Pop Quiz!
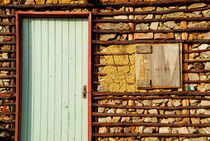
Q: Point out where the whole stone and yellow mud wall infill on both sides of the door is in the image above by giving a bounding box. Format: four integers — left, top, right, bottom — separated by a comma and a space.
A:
0, 0, 210, 141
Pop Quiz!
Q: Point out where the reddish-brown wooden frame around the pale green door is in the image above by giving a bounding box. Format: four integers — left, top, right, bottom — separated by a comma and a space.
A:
15, 11, 92, 141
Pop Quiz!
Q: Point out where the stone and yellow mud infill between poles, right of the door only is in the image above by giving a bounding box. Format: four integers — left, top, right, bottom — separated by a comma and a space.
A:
94, 3, 210, 141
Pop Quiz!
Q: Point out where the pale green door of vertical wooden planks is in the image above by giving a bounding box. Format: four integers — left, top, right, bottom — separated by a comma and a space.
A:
21, 18, 88, 141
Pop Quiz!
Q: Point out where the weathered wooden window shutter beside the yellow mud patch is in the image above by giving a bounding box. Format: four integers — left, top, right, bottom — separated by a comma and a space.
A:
136, 44, 181, 89
